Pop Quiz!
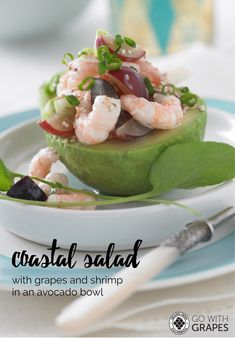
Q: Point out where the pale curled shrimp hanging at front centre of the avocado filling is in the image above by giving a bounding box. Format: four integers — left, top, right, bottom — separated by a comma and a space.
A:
74, 95, 121, 144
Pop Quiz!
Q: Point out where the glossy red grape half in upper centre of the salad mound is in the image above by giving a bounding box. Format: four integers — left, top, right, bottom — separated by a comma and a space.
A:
106, 67, 149, 99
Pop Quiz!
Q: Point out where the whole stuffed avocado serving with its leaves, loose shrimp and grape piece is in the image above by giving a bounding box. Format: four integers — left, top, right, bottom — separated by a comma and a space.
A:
3, 31, 235, 212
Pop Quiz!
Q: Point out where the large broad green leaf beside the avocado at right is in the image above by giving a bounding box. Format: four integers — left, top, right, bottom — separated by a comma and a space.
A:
150, 142, 235, 194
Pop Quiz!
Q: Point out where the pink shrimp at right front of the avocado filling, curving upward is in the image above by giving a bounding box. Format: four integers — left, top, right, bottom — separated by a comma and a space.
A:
121, 95, 183, 129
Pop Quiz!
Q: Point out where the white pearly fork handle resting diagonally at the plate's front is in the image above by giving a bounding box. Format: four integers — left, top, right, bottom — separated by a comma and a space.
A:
56, 246, 180, 333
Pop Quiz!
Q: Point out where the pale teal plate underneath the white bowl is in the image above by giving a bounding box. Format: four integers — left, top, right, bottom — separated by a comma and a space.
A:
0, 99, 235, 290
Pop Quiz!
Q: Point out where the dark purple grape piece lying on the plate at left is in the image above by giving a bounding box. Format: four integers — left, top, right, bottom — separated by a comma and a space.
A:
7, 176, 47, 202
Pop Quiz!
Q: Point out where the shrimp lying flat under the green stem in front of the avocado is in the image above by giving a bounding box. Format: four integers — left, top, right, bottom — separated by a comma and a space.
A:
47, 193, 96, 210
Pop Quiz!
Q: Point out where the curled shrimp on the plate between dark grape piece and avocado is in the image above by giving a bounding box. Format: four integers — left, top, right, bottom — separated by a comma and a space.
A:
28, 148, 59, 178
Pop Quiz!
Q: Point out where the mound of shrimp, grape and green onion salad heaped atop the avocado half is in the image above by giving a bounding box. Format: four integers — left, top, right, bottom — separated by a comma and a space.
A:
39, 31, 200, 145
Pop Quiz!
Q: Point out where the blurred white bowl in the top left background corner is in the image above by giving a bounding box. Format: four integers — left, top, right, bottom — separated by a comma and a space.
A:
0, 0, 89, 40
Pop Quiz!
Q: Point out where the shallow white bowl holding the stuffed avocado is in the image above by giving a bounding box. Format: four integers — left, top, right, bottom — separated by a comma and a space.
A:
0, 109, 235, 250
